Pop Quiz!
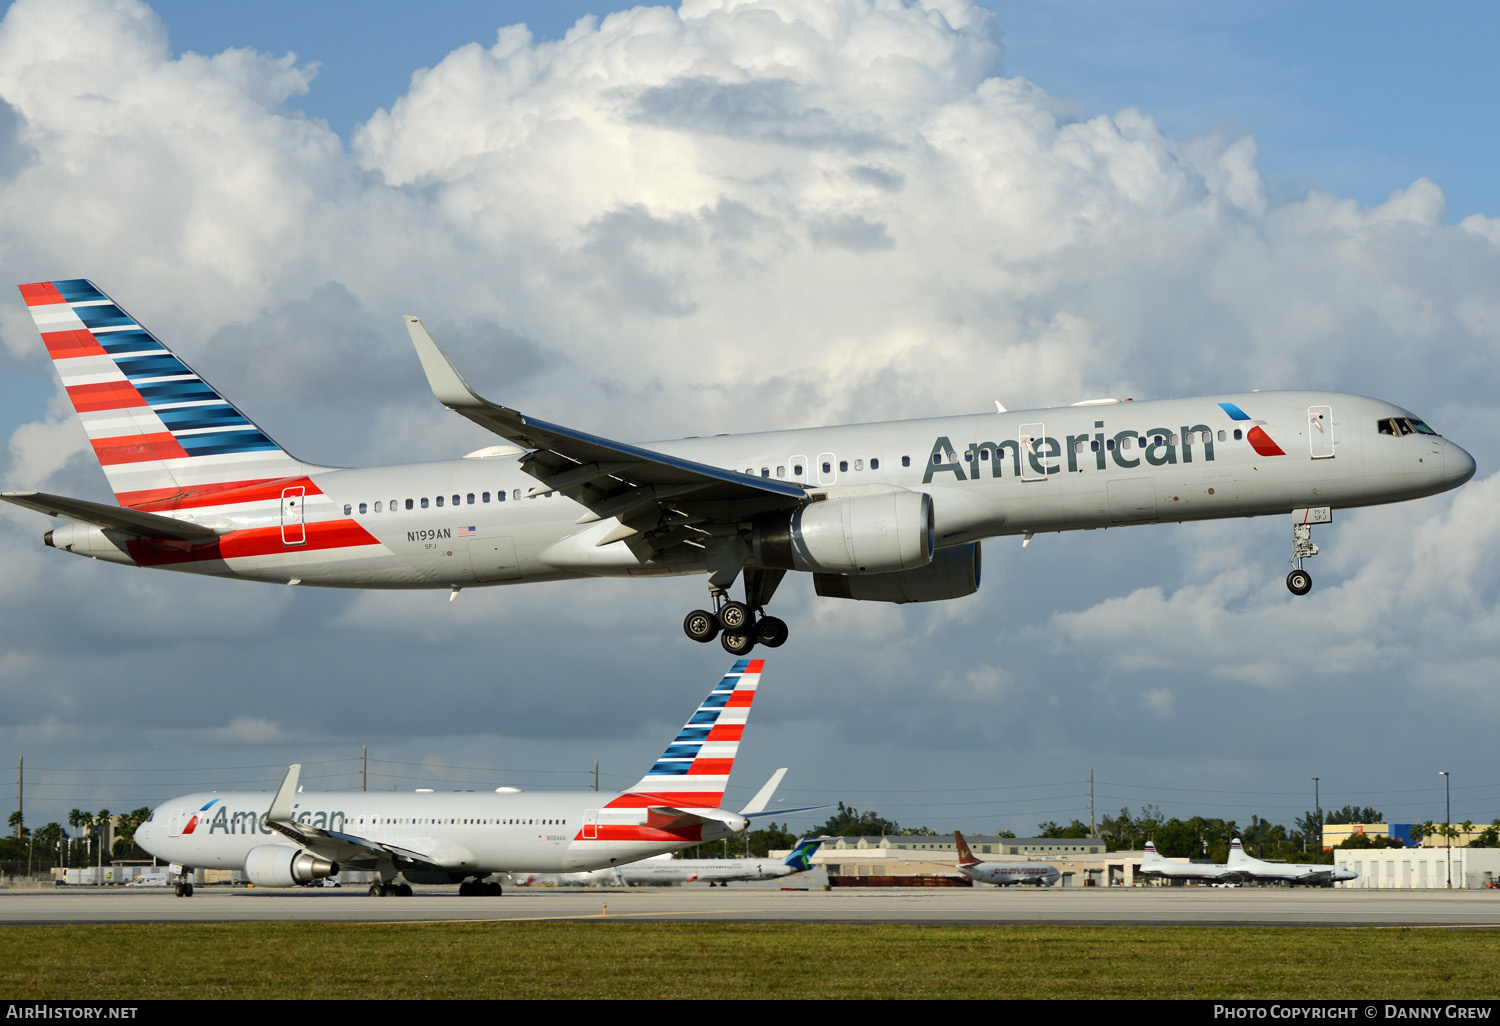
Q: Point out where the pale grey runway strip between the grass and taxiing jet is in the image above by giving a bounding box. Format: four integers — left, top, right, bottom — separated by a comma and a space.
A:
0, 887, 1500, 929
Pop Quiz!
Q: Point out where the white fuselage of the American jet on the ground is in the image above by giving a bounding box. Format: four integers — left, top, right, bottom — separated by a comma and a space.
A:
135, 791, 734, 881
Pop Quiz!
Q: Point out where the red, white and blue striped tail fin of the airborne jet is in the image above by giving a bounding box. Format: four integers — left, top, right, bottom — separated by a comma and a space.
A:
20, 278, 320, 510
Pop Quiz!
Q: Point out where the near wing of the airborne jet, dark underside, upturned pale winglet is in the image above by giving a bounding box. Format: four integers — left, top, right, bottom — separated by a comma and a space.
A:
407, 317, 807, 551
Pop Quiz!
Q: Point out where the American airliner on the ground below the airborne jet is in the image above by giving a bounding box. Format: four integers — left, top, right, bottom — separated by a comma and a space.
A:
135, 659, 780, 897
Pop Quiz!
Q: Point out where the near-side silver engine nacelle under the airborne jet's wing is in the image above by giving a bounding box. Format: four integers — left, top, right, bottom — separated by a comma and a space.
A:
752, 489, 938, 575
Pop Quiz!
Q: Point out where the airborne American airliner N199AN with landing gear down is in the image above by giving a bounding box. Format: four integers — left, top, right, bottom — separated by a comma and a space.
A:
0, 279, 1475, 656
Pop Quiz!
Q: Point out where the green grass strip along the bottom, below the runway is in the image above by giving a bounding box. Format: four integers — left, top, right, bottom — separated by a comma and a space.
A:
0, 923, 1500, 1001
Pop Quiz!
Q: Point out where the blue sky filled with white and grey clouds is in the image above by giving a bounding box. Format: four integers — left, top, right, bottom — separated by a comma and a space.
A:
0, 0, 1500, 833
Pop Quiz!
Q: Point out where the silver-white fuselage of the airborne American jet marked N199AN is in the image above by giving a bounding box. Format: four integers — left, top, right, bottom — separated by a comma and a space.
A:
105, 392, 1475, 588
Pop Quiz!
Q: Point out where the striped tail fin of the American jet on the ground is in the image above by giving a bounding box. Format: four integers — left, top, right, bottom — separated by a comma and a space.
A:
609, 659, 765, 809
